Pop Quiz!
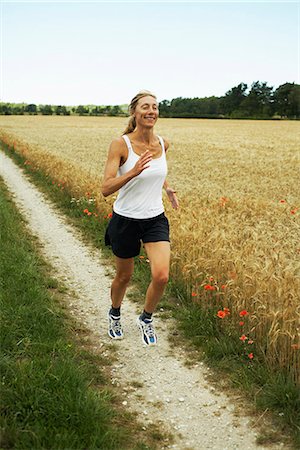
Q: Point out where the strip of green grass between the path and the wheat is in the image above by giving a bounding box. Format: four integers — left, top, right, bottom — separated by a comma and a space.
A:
1, 142, 300, 448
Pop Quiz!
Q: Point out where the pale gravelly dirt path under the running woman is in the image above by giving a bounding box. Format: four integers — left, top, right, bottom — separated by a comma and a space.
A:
0, 152, 282, 450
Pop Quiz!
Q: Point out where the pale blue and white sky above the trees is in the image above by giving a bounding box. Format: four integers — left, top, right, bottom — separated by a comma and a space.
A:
0, 0, 300, 105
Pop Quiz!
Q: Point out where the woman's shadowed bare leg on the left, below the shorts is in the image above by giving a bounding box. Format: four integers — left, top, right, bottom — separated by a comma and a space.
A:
111, 256, 134, 308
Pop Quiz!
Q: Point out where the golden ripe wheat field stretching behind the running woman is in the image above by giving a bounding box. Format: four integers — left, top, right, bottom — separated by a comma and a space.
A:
0, 116, 300, 383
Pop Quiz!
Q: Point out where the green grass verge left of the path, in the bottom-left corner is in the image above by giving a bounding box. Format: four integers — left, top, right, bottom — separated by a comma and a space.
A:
0, 178, 158, 450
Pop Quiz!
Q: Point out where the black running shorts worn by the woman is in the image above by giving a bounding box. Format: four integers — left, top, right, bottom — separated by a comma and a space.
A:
105, 212, 170, 258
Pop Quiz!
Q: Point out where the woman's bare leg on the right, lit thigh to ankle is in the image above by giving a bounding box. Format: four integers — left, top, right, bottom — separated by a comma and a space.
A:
144, 241, 170, 313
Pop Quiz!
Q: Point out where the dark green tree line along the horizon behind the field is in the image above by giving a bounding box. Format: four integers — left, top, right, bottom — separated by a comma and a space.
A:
0, 81, 300, 119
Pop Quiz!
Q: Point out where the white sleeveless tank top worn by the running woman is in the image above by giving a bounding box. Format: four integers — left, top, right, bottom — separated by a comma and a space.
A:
113, 134, 168, 219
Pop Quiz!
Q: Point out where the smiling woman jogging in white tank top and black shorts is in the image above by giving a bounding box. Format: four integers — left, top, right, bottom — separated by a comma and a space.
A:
102, 91, 178, 345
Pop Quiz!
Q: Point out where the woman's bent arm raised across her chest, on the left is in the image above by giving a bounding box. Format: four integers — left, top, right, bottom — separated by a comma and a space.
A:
101, 138, 152, 197
